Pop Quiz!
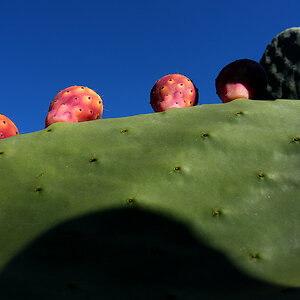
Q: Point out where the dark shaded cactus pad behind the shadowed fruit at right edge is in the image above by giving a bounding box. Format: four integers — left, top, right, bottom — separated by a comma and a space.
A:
260, 27, 300, 100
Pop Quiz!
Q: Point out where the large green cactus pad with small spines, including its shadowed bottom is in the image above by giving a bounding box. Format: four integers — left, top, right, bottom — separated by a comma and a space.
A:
0, 99, 300, 300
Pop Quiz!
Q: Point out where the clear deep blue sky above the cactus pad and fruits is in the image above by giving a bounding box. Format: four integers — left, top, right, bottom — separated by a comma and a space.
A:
0, 0, 300, 134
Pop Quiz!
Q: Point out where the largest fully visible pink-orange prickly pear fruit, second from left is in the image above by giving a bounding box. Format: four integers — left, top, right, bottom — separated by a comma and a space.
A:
45, 85, 103, 127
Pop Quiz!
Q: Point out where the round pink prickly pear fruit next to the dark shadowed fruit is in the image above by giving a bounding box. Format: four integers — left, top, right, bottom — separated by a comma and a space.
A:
150, 74, 198, 112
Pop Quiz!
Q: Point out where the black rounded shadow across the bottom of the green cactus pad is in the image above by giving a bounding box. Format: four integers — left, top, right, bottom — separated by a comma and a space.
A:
0, 208, 300, 300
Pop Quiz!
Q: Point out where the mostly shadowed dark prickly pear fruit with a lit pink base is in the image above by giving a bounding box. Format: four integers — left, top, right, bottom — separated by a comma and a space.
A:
215, 58, 267, 103
